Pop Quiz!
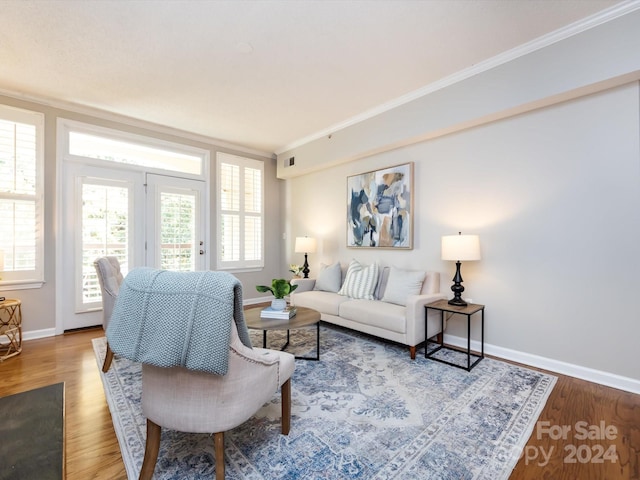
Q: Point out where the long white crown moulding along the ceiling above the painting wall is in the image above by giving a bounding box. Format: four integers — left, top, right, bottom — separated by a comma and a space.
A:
275, 0, 640, 155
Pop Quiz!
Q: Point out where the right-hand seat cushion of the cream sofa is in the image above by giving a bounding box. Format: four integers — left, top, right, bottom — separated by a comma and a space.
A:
340, 300, 407, 333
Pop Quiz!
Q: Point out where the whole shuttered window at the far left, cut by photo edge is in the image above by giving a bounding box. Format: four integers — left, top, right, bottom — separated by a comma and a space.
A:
0, 105, 44, 289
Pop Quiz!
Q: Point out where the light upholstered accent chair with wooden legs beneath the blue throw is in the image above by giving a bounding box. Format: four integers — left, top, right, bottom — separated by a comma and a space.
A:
140, 322, 295, 480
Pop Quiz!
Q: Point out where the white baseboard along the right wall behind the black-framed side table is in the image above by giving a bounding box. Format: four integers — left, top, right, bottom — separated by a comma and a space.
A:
444, 333, 640, 394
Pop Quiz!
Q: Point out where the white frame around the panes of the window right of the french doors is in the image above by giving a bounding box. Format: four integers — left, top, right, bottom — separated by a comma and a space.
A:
216, 152, 265, 272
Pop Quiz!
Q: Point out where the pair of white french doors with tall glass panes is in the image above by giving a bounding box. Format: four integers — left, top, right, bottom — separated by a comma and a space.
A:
59, 162, 207, 330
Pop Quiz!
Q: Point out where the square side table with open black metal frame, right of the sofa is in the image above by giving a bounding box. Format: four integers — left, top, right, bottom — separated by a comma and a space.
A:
424, 300, 484, 372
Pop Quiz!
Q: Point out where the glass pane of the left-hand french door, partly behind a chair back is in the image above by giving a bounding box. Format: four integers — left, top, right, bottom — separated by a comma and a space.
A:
81, 183, 130, 306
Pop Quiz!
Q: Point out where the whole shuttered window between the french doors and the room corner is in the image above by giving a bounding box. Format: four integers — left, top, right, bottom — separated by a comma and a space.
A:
216, 153, 264, 269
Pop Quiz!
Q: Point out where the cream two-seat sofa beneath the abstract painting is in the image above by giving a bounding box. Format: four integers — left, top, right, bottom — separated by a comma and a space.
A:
290, 260, 446, 359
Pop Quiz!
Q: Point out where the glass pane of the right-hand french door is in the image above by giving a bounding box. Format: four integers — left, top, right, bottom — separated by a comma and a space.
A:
160, 192, 198, 272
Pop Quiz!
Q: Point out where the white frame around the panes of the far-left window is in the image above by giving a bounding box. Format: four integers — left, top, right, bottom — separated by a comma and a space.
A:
0, 105, 45, 291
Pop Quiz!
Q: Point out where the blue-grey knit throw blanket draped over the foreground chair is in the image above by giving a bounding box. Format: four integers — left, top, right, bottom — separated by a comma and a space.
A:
107, 268, 251, 375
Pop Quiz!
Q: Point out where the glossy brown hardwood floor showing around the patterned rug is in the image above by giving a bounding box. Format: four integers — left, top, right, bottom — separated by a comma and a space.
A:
0, 329, 640, 480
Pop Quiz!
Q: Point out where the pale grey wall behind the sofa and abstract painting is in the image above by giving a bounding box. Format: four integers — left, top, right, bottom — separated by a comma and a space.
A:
286, 82, 640, 380
